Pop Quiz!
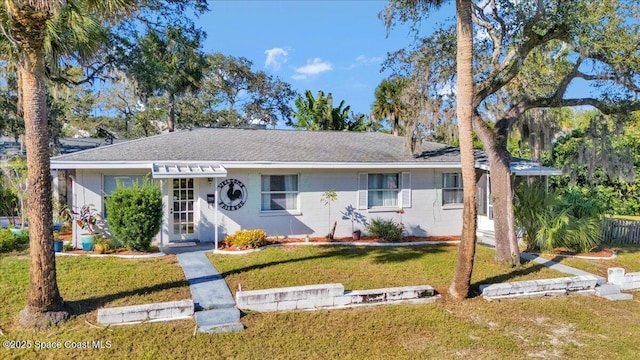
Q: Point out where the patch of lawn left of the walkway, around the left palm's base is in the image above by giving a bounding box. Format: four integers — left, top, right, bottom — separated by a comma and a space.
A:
0, 255, 191, 329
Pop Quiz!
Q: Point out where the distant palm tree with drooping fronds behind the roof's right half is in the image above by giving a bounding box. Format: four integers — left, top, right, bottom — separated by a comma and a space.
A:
371, 78, 405, 136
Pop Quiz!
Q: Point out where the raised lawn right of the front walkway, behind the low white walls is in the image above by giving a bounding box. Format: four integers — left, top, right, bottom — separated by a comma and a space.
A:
209, 245, 569, 293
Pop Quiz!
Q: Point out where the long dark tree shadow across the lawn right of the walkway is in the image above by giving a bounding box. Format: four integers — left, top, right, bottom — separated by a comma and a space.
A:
221, 245, 446, 278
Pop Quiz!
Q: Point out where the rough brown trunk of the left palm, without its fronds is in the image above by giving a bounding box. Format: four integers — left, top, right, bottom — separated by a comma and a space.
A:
18, 52, 68, 328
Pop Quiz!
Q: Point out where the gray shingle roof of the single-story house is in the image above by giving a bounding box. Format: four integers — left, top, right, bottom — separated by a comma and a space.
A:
52, 128, 460, 163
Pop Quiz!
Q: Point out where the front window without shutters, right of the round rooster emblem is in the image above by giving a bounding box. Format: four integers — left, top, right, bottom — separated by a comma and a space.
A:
261, 175, 298, 211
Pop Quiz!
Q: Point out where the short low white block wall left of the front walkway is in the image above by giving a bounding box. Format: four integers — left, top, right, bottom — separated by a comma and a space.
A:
98, 299, 194, 325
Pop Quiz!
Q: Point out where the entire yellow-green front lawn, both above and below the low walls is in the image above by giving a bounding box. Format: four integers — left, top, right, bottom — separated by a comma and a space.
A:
0, 246, 640, 359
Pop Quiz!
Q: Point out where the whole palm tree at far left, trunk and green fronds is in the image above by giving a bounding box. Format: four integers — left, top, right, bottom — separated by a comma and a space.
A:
0, 0, 136, 328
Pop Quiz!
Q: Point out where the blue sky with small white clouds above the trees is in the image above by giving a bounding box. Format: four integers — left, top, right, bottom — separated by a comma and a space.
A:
196, 0, 453, 121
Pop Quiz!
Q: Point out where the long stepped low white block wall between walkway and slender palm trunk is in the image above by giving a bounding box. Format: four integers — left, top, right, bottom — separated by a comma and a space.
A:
236, 283, 440, 312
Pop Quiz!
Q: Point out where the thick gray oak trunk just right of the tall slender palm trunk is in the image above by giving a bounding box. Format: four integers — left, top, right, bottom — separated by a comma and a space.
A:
474, 117, 520, 266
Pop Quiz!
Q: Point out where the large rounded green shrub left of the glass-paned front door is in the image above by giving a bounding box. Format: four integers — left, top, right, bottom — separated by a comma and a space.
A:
105, 180, 162, 251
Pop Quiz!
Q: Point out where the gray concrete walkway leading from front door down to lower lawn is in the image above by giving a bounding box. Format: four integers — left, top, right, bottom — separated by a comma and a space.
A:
174, 244, 244, 332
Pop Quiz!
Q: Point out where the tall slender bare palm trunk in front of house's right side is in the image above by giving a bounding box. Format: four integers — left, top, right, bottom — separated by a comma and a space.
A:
449, 0, 477, 299
